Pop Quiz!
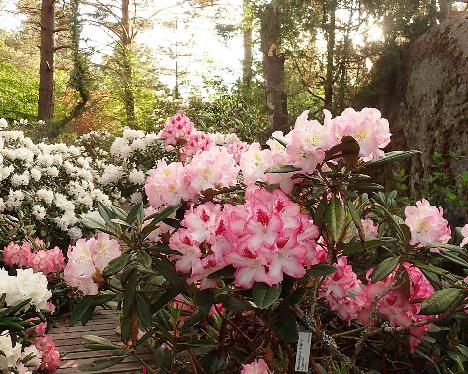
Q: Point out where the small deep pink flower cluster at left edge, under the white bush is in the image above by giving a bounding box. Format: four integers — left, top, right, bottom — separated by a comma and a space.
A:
3, 238, 65, 276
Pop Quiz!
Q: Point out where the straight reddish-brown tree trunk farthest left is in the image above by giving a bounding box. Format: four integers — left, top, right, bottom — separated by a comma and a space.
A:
38, 0, 55, 121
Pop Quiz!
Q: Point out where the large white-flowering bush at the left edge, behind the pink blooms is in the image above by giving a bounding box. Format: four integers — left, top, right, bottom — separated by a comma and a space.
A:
0, 127, 110, 239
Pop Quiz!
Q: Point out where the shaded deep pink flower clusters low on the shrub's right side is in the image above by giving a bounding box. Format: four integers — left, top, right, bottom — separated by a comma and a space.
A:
319, 257, 435, 351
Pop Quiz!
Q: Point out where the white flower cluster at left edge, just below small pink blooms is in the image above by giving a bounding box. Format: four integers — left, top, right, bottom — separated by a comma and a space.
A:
0, 268, 52, 310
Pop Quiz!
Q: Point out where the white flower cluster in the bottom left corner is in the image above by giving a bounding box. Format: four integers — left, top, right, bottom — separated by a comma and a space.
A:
0, 332, 42, 374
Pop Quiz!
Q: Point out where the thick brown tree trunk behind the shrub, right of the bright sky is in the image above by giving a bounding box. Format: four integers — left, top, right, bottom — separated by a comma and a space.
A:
260, 4, 288, 131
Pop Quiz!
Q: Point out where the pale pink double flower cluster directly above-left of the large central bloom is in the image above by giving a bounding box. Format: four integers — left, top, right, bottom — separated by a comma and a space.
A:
145, 146, 239, 209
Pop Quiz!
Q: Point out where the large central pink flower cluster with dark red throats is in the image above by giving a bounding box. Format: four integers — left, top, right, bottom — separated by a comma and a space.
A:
170, 187, 319, 288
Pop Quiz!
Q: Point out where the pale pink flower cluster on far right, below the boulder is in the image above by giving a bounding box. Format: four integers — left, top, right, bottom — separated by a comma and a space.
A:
405, 199, 451, 247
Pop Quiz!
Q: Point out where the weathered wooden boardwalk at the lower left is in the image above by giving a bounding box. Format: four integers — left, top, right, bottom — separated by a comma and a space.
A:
50, 310, 152, 374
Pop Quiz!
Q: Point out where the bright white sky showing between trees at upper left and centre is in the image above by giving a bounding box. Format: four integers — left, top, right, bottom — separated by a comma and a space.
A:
0, 0, 243, 94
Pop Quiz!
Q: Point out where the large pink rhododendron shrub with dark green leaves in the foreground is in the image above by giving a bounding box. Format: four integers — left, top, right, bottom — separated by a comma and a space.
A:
65, 108, 468, 374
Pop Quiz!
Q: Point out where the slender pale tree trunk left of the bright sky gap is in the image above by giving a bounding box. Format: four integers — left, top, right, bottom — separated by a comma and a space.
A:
120, 0, 135, 126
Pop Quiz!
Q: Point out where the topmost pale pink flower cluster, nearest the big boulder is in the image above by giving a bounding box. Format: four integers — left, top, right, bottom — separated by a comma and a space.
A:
325, 108, 391, 160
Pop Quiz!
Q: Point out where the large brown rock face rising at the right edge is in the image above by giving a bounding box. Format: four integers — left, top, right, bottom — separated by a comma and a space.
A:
383, 17, 468, 221
